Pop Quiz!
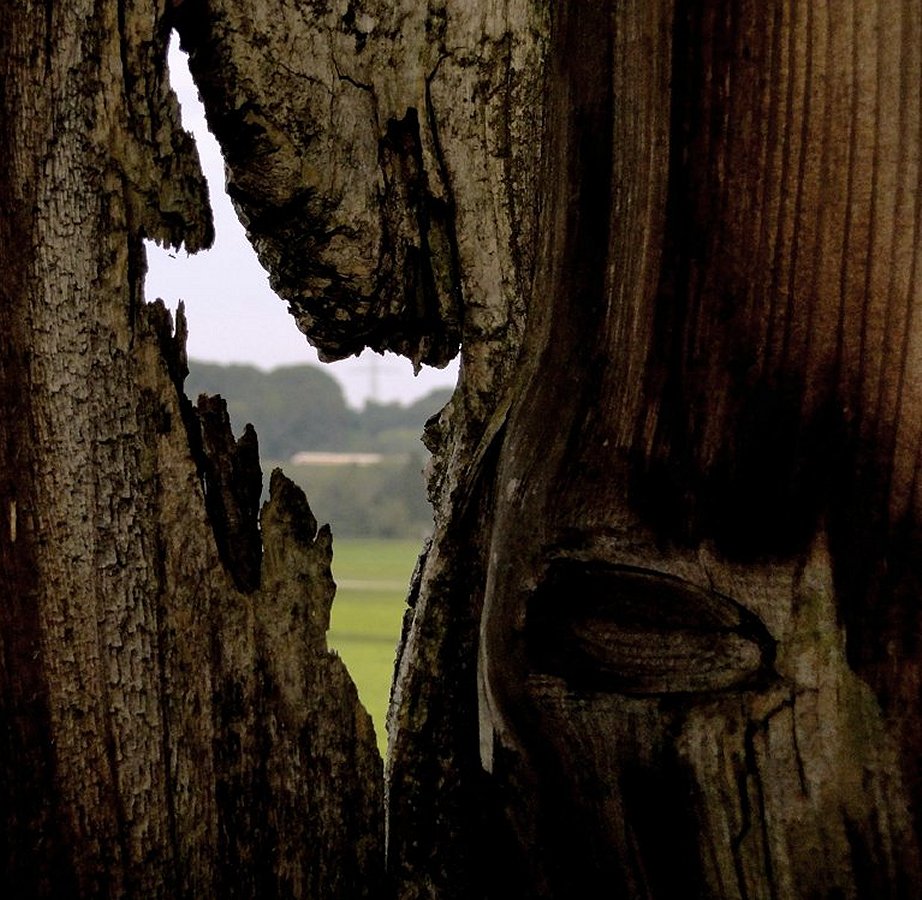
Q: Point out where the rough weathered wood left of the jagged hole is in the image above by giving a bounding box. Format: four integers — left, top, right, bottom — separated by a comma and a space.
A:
0, 0, 383, 897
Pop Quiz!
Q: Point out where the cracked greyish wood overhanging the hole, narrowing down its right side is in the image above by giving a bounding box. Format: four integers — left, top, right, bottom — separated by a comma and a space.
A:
179, 0, 548, 897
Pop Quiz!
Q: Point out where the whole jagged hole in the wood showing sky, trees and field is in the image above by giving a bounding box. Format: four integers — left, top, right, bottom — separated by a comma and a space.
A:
154, 38, 458, 752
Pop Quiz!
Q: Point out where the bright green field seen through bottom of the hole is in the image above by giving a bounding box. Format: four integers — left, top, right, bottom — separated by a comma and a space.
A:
329, 537, 422, 753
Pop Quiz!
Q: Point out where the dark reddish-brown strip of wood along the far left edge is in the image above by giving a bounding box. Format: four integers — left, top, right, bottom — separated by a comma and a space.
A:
0, 7, 72, 893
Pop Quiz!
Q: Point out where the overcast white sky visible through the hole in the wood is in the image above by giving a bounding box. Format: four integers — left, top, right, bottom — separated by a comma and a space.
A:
146, 39, 457, 407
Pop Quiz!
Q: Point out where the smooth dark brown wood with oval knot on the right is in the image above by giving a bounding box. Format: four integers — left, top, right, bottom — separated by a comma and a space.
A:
480, 2, 922, 897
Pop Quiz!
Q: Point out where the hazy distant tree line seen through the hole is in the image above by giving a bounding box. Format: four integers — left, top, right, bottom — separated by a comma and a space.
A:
186, 360, 451, 539
